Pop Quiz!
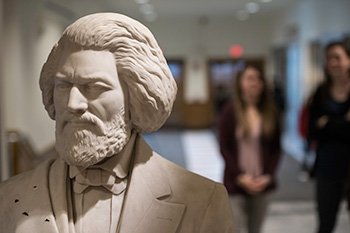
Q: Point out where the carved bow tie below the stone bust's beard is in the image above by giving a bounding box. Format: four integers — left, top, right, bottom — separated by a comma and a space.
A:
73, 168, 127, 195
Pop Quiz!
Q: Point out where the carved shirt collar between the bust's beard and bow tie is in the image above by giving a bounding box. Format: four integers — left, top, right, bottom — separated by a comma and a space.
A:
69, 132, 137, 179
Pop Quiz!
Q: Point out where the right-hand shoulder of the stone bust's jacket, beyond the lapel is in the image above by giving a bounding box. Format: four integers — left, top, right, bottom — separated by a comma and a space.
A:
154, 154, 233, 233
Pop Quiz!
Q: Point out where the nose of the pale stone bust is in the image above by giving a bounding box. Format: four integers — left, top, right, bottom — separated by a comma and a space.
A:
67, 85, 88, 114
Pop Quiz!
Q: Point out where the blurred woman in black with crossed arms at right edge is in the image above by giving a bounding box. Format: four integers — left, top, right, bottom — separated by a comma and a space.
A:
308, 42, 350, 233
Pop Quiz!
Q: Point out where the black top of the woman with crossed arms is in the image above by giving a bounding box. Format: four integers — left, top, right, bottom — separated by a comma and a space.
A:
308, 87, 350, 180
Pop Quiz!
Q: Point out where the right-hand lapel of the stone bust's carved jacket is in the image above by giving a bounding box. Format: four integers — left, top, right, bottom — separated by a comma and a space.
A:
118, 136, 185, 233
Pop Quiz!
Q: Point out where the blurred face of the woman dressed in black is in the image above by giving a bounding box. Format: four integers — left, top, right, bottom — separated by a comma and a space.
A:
325, 45, 350, 81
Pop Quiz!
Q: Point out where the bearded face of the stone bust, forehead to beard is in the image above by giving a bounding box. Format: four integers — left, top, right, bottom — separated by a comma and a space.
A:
54, 50, 130, 167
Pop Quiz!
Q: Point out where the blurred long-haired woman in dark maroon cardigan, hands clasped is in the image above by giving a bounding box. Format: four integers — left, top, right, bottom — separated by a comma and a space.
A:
219, 65, 280, 233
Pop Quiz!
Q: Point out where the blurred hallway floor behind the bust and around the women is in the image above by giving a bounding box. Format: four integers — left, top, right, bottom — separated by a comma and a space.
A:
143, 129, 350, 233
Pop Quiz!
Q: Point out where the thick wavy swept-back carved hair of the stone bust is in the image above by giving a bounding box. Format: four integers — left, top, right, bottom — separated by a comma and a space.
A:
40, 13, 177, 133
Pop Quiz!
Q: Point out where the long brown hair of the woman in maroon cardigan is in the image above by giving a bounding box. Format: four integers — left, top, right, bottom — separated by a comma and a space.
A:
233, 65, 277, 139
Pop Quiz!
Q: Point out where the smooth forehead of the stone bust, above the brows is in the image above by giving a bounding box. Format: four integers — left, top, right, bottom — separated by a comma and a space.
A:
56, 50, 117, 83
